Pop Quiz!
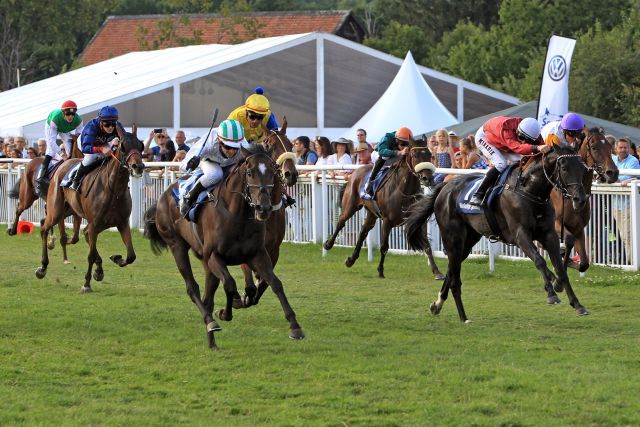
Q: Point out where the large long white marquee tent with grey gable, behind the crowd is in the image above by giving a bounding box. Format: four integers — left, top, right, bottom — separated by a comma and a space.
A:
0, 33, 519, 139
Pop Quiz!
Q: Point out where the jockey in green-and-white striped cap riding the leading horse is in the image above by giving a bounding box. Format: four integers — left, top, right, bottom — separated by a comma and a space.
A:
180, 119, 249, 216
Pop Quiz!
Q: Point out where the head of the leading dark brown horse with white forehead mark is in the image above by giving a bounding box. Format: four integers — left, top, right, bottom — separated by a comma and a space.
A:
240, 144, 282, 221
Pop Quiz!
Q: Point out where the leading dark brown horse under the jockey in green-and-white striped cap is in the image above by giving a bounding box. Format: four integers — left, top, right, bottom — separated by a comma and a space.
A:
145, 144, 304, 349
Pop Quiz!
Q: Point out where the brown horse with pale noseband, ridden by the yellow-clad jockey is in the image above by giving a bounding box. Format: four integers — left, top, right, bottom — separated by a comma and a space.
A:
239, 117, 298, 308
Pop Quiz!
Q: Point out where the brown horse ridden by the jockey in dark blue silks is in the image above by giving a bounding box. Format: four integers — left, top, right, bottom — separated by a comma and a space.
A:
36, 125, 144, 293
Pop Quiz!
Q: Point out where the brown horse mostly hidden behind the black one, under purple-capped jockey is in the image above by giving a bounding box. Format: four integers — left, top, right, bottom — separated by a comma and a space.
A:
551, 128, 618, 272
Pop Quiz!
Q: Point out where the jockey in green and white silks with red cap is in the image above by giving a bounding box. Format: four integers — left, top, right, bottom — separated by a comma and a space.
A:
35, 101, 83, 196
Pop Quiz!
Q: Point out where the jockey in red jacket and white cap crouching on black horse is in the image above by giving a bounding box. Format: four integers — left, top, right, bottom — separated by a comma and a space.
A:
469, 116, 550, 206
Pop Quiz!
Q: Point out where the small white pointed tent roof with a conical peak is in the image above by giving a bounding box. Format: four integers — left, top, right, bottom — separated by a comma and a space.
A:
345, 52, 458, 141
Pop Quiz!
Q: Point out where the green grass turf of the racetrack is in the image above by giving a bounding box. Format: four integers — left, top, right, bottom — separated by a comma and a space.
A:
0, 227, 640, 426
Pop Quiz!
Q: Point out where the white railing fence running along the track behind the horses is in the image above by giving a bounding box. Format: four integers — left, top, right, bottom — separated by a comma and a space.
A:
0, 159, 640, 271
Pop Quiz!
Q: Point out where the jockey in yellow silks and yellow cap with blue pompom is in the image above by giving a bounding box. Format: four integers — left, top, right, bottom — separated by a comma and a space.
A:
227, 87, 278, 143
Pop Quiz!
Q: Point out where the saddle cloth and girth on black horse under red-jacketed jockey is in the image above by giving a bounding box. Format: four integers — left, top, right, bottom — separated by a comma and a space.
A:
456, 163, 518, 240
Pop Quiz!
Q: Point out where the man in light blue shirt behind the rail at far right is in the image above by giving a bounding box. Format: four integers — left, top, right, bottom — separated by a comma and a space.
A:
611, 138, 640, 258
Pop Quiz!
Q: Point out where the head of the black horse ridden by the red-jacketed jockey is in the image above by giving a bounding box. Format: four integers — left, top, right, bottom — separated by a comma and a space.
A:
542, 145, 587, 209
